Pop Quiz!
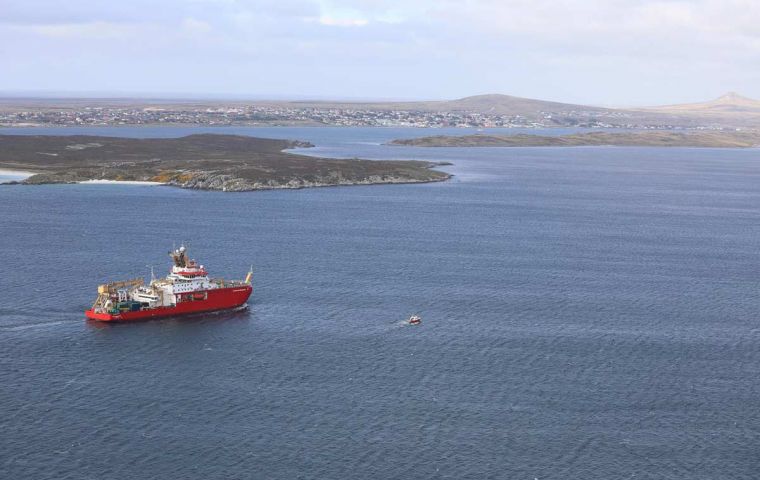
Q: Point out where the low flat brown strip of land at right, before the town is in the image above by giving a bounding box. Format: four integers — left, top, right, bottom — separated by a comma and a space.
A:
388, 130, 760, 148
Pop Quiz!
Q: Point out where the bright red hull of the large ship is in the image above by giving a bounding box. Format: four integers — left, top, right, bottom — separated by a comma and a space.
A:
84, 285, 253, 322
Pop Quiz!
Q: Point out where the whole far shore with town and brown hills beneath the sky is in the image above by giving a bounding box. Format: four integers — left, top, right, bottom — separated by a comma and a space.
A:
0, 92, 760, 129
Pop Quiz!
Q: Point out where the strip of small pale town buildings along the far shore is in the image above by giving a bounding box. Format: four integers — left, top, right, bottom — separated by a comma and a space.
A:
0, 105, 649, 128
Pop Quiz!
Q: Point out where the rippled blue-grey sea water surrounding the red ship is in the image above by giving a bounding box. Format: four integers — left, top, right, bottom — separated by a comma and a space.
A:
0, 127, 760, 480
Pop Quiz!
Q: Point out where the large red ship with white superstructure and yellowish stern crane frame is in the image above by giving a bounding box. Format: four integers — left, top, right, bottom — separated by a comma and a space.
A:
85, 245, 253, 322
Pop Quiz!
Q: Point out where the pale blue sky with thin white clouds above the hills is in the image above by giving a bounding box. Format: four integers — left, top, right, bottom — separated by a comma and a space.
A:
0, 0, 760, 106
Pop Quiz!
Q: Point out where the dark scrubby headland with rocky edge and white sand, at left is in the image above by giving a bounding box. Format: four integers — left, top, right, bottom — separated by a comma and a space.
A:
0, 134, 450, 192
